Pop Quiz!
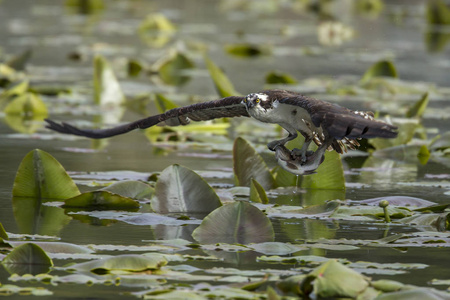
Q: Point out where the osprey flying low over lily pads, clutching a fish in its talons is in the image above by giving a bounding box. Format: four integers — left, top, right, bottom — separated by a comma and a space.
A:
45, 90, 397, 174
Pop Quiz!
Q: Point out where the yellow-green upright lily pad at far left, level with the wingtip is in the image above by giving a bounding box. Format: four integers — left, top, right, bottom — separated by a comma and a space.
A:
4, 93, 48, 117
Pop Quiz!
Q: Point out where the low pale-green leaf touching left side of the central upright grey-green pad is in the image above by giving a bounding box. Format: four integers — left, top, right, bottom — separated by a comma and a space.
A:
101, 180, 154, 200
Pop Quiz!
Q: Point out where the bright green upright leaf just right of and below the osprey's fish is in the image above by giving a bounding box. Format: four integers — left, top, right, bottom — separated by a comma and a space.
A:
301, 151, 345, 190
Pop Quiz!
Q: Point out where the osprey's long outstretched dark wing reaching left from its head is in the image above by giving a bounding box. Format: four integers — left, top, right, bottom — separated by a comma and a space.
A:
45, 96, 249, 139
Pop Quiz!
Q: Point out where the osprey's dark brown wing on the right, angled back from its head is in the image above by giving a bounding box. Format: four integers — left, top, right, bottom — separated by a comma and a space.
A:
268, 91, 397, 140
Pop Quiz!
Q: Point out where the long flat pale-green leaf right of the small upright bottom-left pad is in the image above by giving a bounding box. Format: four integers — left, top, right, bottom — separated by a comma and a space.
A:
66, 253, 167, 275
